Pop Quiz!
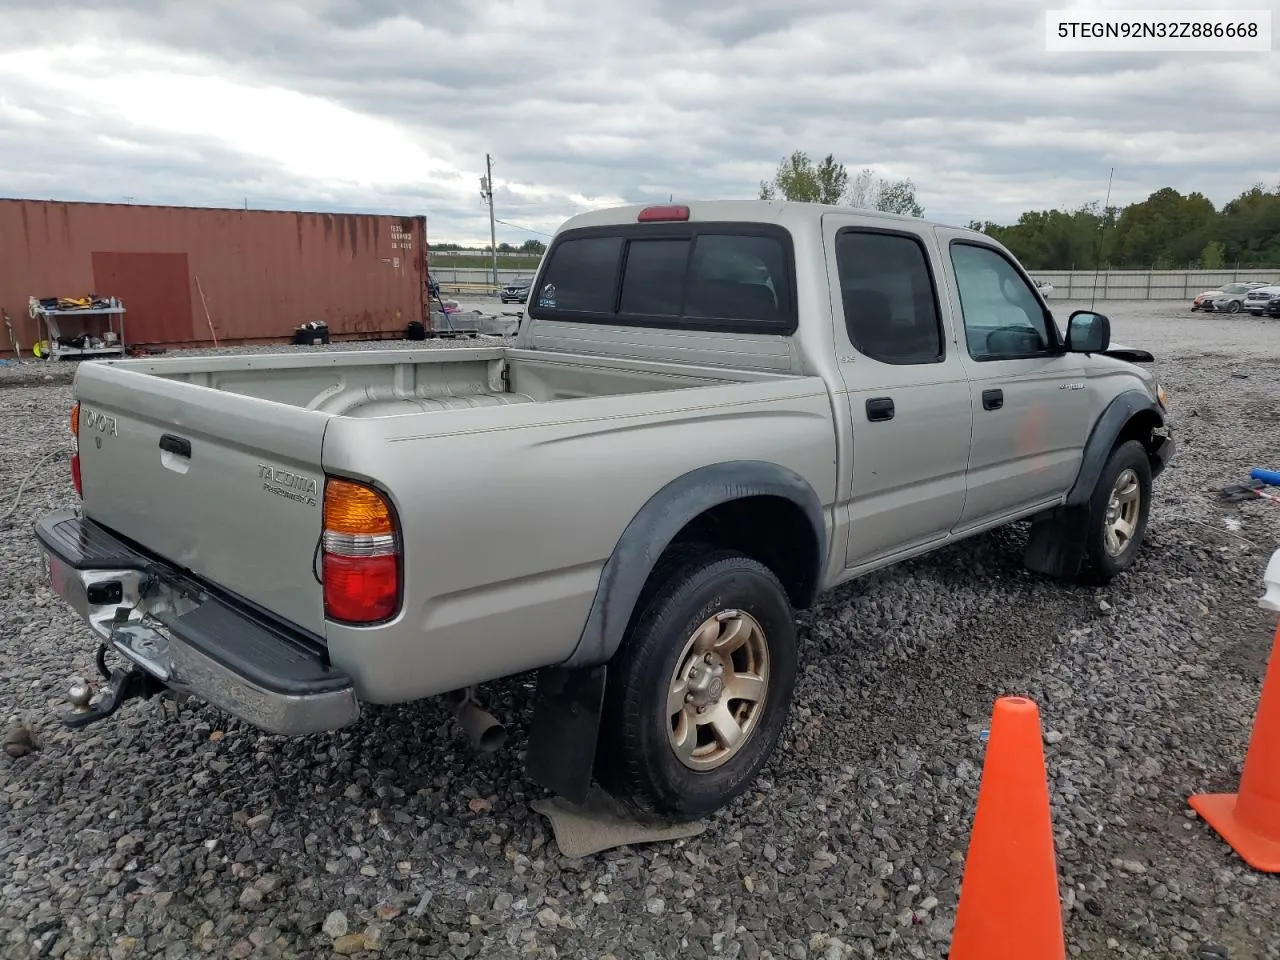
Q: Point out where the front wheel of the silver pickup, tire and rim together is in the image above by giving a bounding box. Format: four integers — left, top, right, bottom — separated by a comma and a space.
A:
1088, 440, 1151, 581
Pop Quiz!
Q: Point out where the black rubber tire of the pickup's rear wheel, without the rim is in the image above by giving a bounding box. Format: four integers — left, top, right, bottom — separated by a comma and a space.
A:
596, 545, 796, 819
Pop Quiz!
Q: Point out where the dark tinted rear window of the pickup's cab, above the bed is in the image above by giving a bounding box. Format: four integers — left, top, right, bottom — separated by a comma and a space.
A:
529, 223, 796, 334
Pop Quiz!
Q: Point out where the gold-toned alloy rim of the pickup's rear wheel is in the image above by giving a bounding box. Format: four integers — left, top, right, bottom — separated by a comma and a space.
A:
667, 611, 769, 772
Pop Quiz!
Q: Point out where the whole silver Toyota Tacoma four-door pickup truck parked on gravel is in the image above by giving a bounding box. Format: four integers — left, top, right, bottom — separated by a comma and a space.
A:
36, 201, 1174, 817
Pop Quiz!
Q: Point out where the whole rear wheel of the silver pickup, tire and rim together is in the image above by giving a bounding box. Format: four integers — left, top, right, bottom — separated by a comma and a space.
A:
598, 549, 796, 819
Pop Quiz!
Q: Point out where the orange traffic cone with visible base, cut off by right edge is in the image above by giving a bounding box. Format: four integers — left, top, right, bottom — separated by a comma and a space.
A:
1188, 616, 1280, 873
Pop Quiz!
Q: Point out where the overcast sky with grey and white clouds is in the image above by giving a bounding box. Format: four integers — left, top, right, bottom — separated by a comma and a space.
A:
0, 0, 1280, 243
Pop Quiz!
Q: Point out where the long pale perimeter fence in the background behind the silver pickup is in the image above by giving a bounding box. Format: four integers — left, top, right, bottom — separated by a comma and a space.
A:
431, 267, 1280, 301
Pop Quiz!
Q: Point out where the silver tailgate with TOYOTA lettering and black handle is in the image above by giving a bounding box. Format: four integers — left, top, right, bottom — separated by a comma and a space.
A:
76, 362, 329, 635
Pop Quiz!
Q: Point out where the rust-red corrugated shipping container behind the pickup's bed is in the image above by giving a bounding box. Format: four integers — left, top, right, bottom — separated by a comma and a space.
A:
0, 200, 430, 353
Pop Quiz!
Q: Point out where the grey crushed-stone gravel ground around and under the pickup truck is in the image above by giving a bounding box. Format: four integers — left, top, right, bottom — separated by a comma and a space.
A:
0, 302, 1280, 960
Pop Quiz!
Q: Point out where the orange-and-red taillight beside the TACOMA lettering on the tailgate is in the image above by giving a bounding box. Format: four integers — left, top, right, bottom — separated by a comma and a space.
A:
321, 479, 401, 625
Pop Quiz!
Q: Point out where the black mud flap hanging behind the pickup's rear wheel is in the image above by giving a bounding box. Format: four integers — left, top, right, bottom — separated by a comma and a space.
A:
525, 664, 605, 804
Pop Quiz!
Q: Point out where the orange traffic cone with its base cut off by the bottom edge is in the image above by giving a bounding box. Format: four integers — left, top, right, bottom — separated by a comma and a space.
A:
950, 696, 1066, 960
